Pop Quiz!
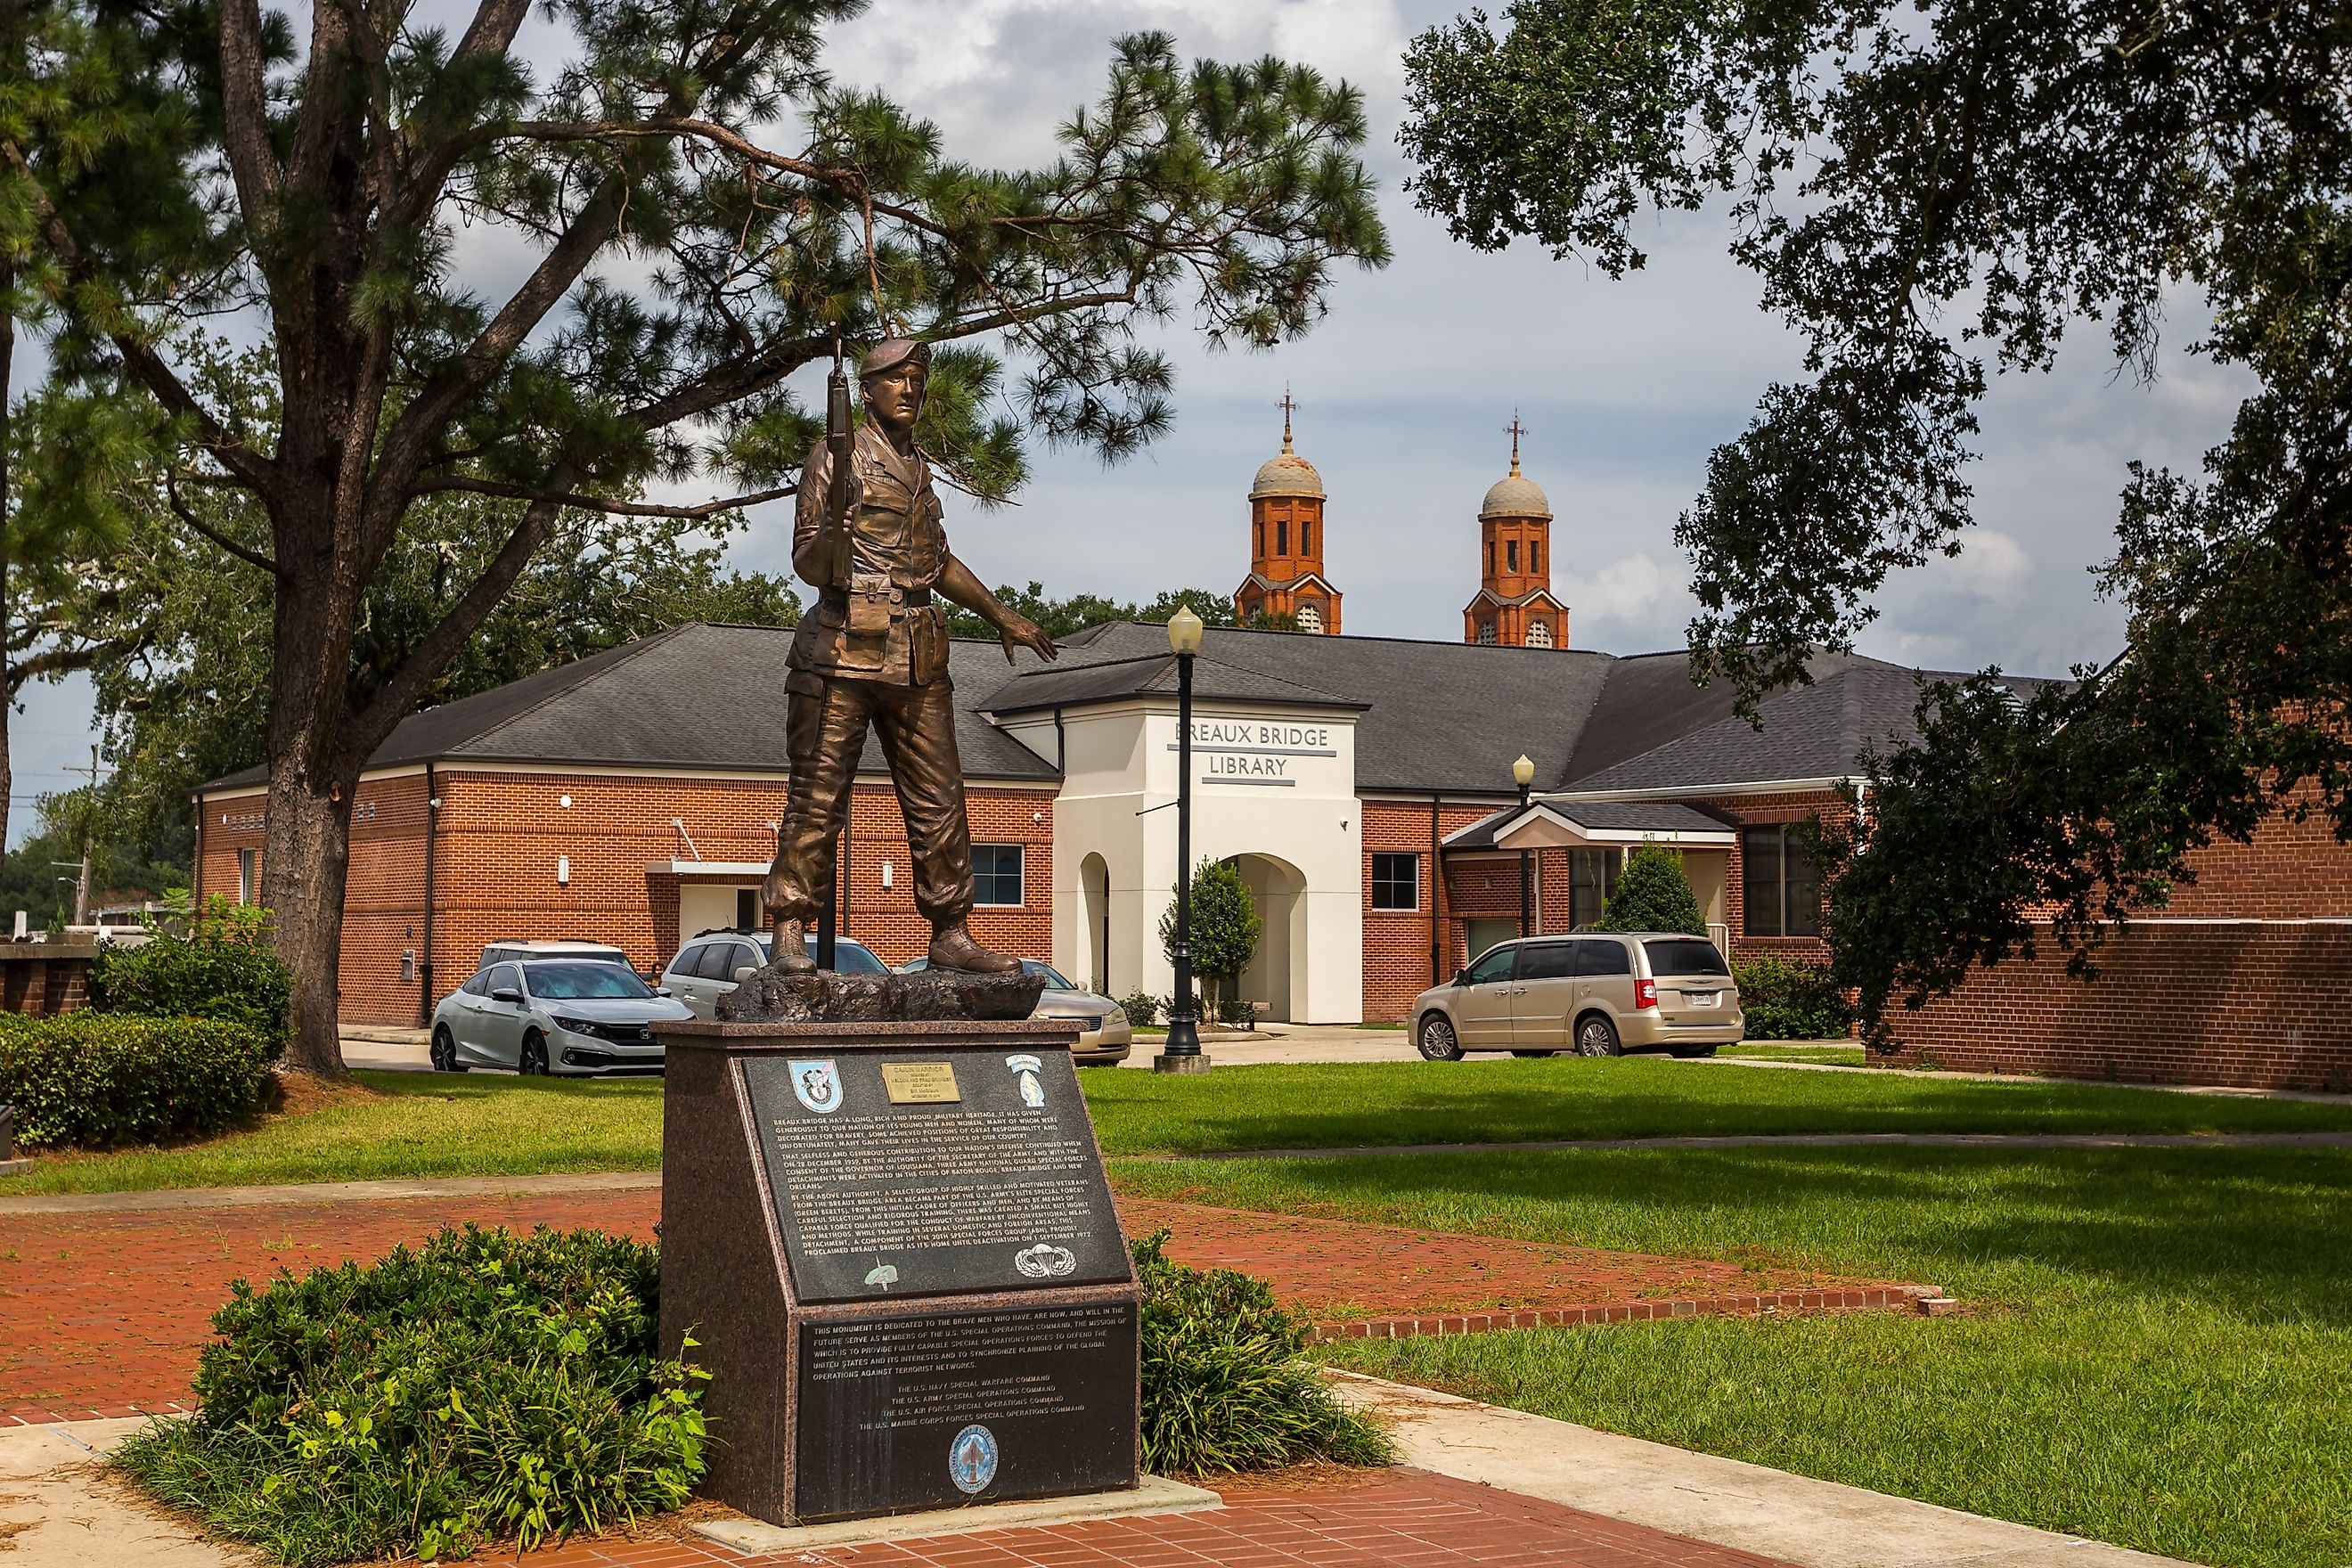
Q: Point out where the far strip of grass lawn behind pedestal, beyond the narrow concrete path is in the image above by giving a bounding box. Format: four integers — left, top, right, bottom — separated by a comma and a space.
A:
13, 1058, 2352, 1196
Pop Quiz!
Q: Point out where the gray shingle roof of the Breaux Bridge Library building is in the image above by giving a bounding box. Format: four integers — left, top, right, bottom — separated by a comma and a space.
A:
202, 623, 2037, 799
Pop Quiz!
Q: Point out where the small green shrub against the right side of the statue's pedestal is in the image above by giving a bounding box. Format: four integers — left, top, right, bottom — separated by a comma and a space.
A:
1133, 1229, 1395, 1474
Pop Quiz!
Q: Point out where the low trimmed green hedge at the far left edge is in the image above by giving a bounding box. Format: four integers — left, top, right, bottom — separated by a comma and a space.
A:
0, 1011, 284, 1149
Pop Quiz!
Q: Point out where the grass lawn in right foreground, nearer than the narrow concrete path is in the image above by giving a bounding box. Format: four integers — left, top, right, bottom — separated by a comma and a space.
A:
1117, 1142, 2352, 1568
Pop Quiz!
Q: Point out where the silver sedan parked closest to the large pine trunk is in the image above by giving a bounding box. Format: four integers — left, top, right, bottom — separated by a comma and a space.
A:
433, 960, 694, 1077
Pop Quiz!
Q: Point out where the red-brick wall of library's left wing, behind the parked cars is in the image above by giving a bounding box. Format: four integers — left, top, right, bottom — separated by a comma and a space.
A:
202, 769, 1054, 1025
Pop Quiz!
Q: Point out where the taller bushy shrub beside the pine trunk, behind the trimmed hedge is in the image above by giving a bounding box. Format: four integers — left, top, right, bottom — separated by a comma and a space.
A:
89, 894, 294, 1060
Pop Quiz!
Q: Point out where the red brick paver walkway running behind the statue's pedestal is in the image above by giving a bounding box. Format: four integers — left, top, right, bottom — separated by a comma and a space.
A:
0, 1189, 1922, 1425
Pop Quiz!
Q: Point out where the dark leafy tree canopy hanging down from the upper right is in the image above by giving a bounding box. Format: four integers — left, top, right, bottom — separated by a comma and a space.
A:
1404, 0, 2352, 1043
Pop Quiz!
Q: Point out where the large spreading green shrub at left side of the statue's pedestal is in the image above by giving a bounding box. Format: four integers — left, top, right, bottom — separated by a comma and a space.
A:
118, 1225, 706, 1564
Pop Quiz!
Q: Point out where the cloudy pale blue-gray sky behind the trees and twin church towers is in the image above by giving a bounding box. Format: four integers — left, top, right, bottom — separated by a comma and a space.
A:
12, 0, 2239, 837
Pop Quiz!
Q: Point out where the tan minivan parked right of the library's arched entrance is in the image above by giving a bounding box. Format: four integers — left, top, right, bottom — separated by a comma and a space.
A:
1411, 931, 1745, 1063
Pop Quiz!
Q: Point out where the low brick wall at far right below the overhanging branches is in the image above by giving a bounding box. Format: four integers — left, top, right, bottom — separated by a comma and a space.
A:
1891, 919, 2352, 1090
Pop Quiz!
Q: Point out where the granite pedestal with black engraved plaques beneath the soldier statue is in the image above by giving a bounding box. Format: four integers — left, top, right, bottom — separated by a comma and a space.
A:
661, 1023, 1139, 1523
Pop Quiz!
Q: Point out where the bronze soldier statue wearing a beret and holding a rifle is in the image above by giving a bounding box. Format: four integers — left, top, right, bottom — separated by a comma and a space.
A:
764, 339, 1056, 973
